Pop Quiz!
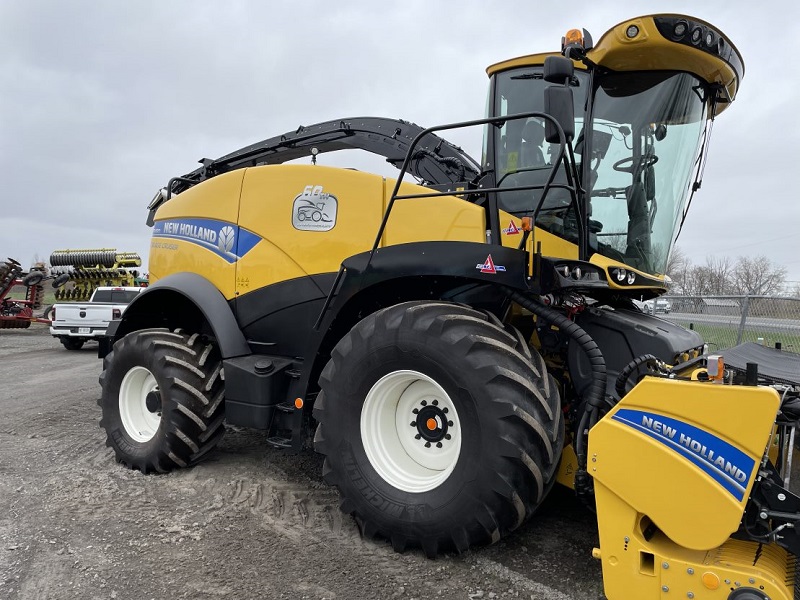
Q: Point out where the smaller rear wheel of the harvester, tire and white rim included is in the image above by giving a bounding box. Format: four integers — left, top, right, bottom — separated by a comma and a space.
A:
98, 329, 225, 473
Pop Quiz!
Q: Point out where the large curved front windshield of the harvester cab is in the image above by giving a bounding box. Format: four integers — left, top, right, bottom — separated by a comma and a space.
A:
584, 72, 706, 274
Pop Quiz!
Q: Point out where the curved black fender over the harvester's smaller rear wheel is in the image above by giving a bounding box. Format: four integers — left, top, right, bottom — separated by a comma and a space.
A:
106, 273, 252, 358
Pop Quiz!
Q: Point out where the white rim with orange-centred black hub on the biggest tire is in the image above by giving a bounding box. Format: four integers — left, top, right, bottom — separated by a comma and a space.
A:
361, 371, 461, 493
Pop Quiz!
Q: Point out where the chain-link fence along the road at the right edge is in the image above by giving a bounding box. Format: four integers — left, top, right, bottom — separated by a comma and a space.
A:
643, 296, 800, 353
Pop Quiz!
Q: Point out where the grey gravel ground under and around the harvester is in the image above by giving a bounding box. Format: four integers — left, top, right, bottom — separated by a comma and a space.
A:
0, 325, 602, 600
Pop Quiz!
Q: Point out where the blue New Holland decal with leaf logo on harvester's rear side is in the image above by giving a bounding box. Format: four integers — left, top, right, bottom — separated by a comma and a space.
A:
153, 219, 261, 263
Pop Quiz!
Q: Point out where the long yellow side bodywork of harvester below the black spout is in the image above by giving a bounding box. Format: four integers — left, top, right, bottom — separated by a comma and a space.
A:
150, 165, 486, 300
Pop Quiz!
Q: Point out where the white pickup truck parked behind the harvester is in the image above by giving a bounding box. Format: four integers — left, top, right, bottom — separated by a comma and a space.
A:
50, 287, 145, 350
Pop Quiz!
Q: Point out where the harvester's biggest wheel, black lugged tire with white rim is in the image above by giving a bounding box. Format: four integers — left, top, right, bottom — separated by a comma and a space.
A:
314, 302, 564, 556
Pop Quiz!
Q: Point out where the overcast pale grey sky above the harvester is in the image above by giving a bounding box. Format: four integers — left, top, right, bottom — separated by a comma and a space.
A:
0, 0, 800, 282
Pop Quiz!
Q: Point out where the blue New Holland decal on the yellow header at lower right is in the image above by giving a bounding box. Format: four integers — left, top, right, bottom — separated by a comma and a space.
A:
612, 408, 755, 502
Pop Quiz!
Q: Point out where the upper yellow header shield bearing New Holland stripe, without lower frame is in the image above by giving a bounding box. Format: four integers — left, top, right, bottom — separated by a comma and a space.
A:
589, 378, 779, 550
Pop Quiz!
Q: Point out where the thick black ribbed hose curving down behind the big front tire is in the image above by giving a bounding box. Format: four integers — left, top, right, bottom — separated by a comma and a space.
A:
506, 289, 606, 500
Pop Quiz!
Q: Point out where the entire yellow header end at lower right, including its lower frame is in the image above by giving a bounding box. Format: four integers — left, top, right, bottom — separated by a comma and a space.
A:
589, 378, 794, 600
